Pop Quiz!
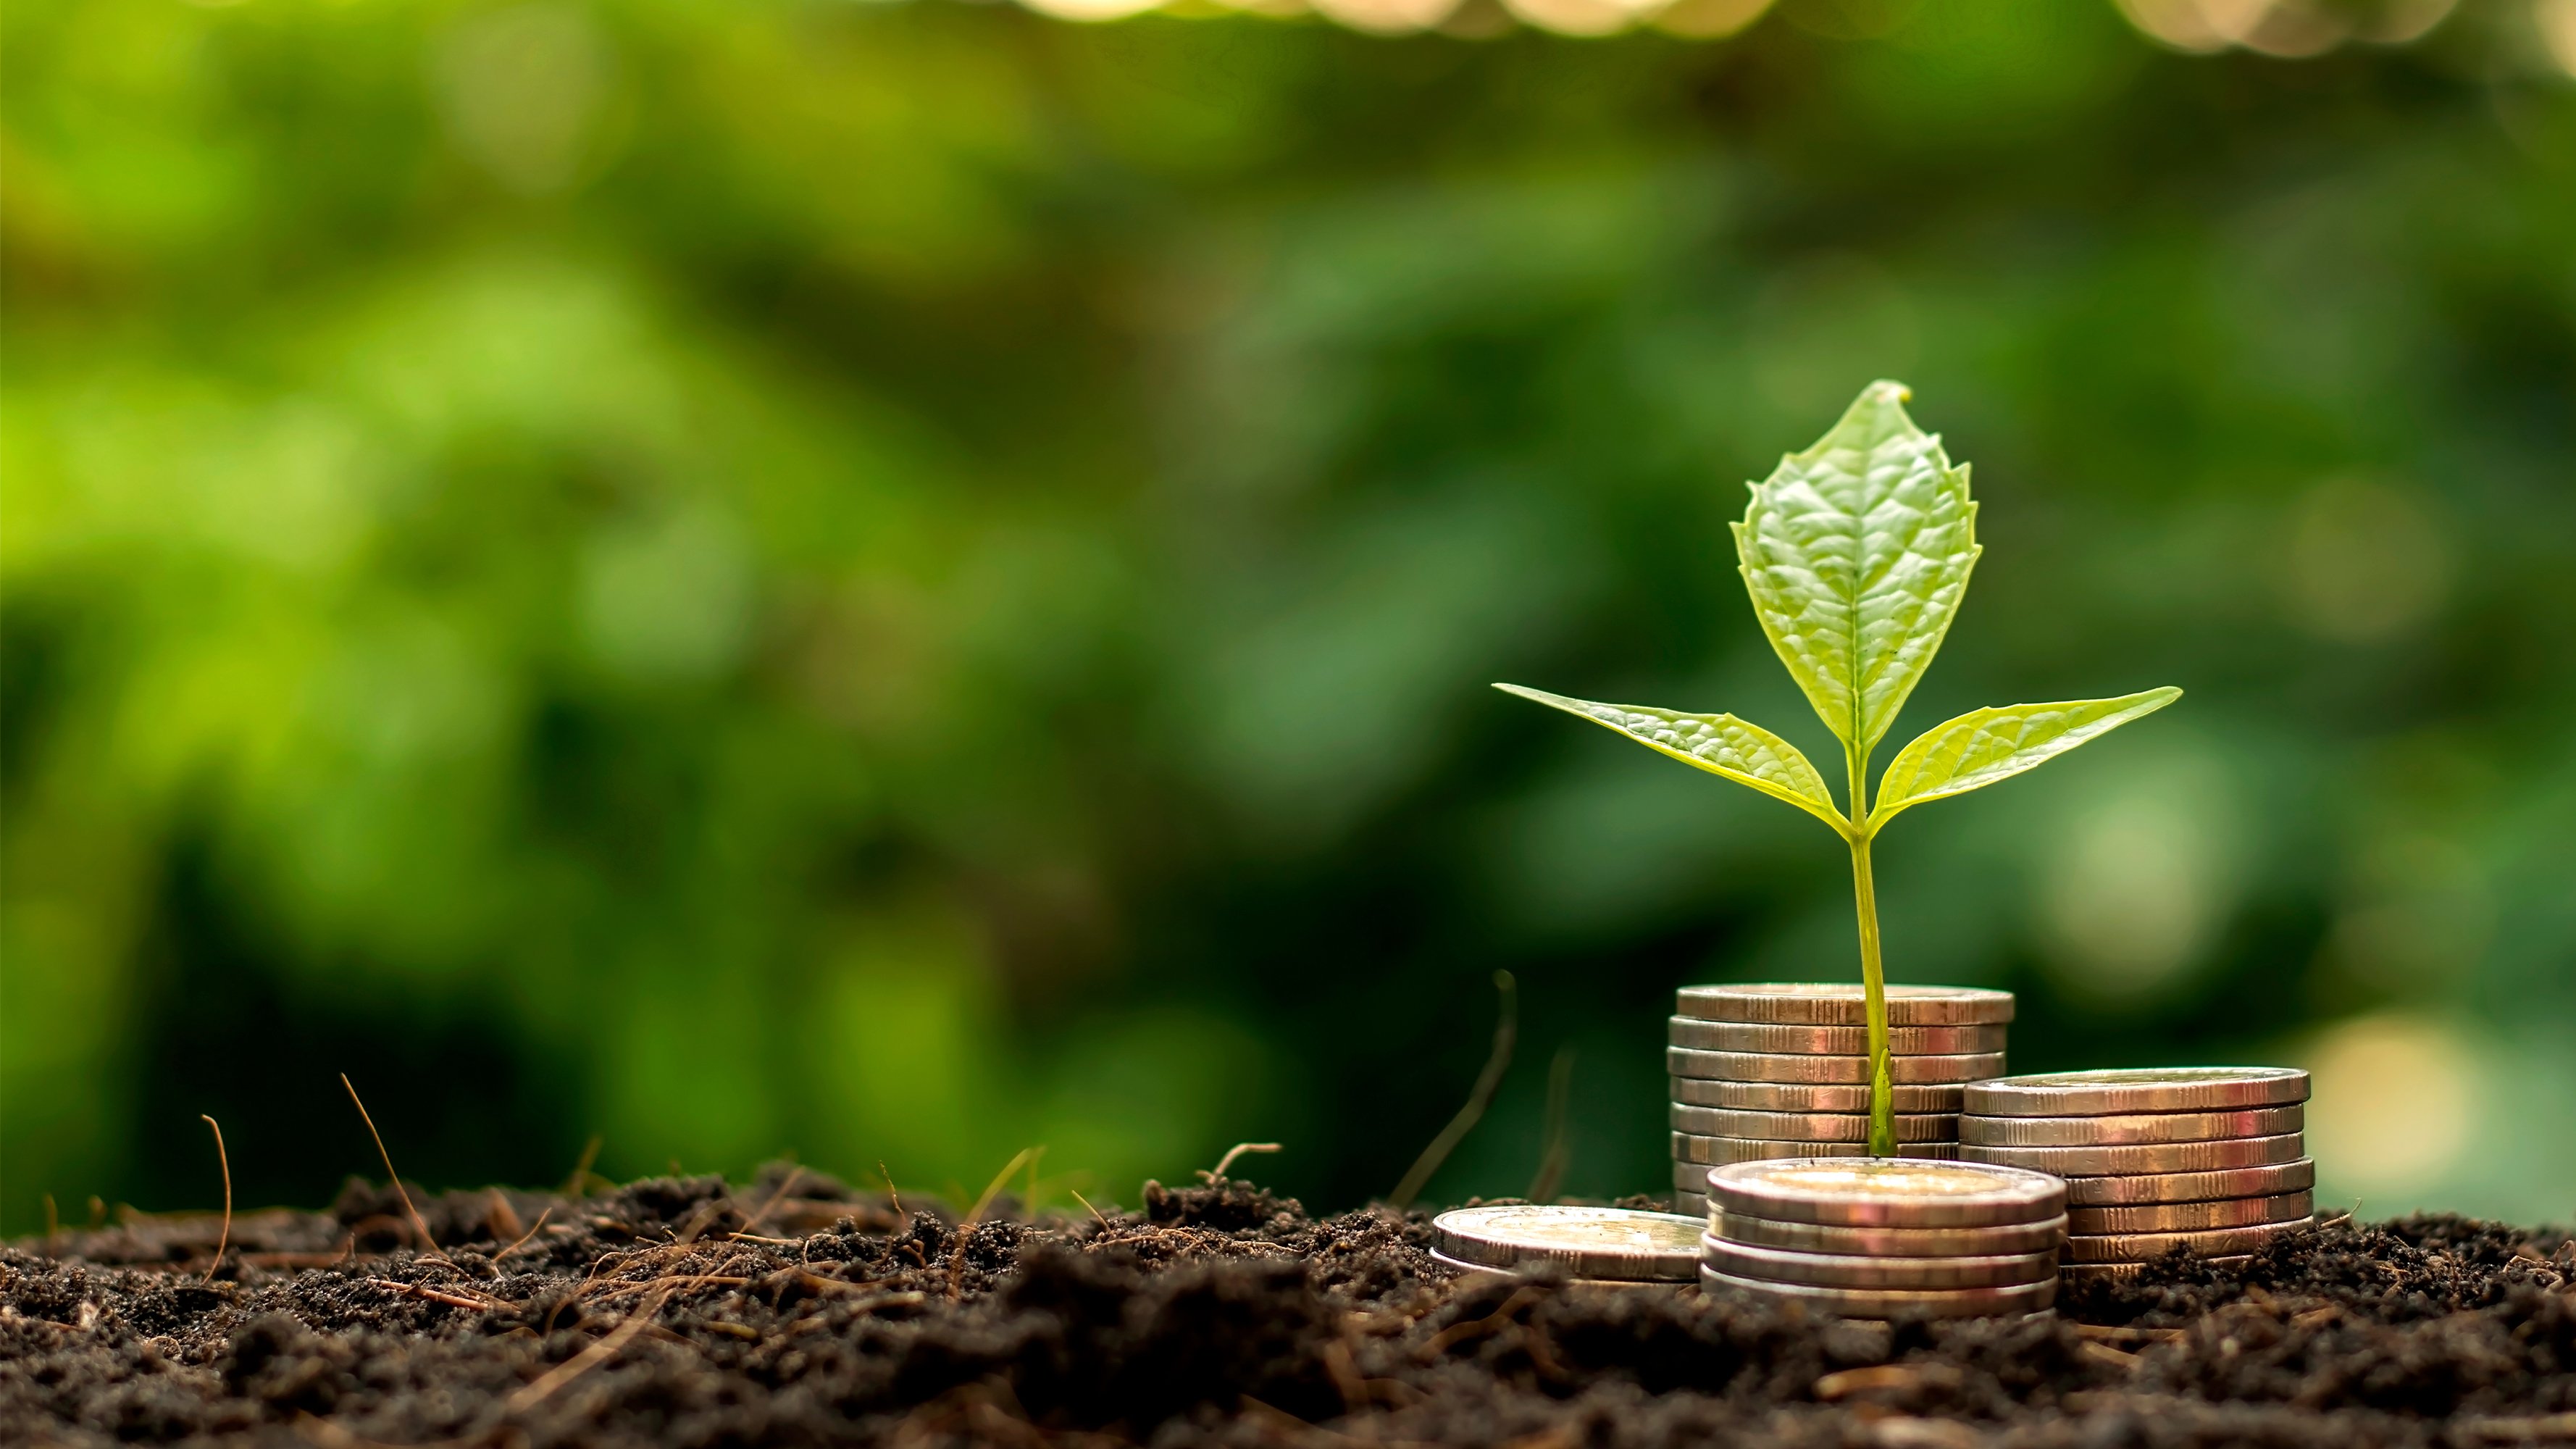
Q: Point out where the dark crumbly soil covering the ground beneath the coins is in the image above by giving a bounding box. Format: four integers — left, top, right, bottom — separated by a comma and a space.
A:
0, 1171, 2576, 1449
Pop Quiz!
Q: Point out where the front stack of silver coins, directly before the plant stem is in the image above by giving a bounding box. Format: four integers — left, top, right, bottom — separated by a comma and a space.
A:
1700, 1158, 2066, 1318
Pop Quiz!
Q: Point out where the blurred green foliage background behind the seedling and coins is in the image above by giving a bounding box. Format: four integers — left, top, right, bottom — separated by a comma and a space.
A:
0, 0, 2576, 1232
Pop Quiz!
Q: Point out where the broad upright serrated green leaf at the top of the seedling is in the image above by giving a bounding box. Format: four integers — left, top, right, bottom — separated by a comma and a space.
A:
1734, 382, 1978, 756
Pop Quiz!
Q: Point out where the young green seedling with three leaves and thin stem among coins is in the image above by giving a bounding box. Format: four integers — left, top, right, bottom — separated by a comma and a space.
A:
1494, 382, 2182, 1158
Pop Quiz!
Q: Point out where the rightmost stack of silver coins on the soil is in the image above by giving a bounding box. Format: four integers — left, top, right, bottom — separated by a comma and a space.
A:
1958, 1067, 2316, 1277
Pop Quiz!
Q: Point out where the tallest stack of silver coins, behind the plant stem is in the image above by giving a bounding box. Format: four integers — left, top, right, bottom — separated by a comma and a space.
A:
1664, 982, 2012, 1214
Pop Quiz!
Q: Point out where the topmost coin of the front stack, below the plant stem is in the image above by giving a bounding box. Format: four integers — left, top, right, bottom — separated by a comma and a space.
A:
1708, 1158, 2066, 1227
